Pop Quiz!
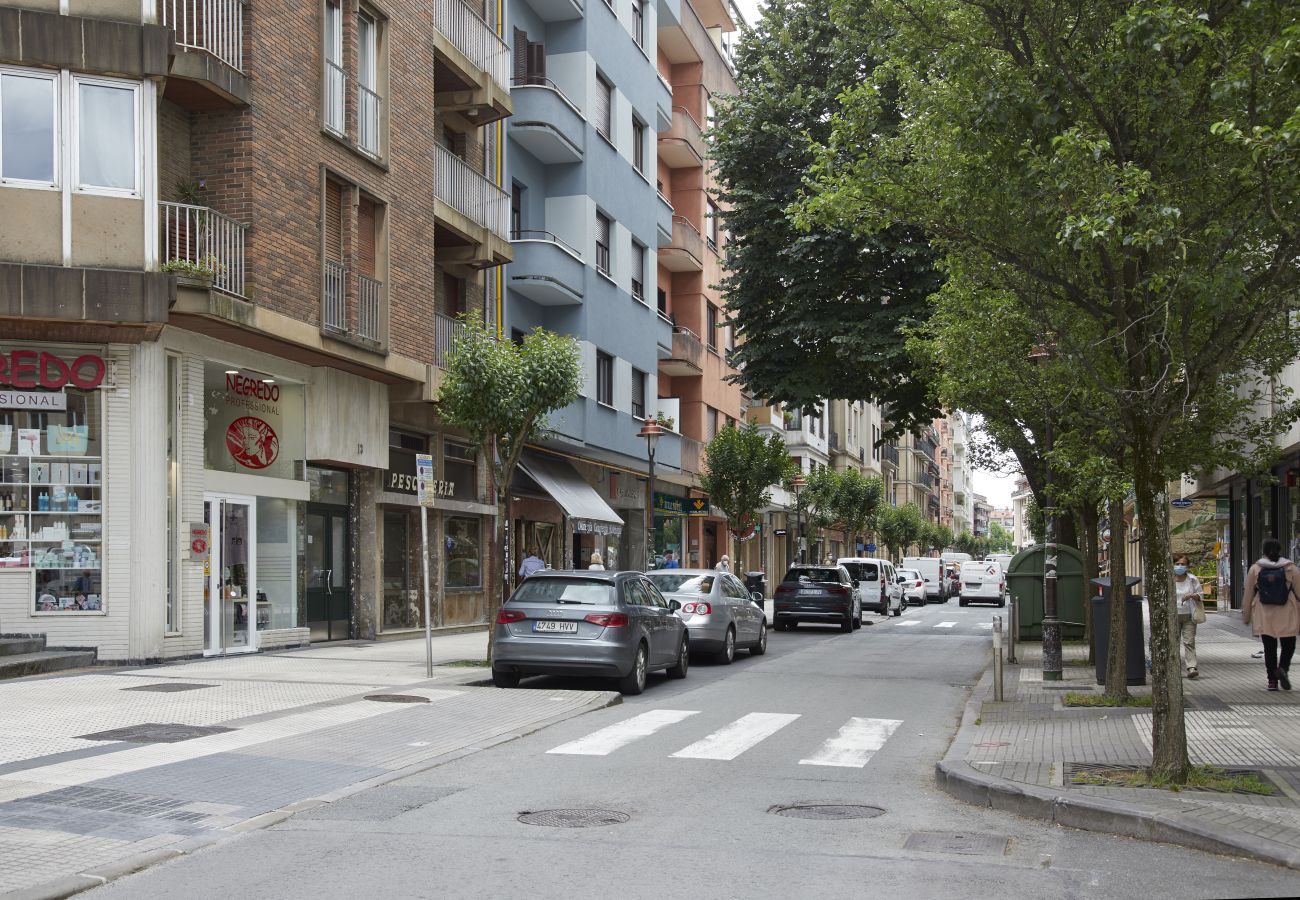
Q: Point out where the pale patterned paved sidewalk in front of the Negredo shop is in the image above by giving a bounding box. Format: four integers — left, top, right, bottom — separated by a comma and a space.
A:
0, 632, 621, 897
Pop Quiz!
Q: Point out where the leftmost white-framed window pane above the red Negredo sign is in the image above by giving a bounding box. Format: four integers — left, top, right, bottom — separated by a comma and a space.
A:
0, 72, 57, 185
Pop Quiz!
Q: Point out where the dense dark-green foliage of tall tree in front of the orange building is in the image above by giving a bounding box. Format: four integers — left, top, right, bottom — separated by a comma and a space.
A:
707, 0, 940, 432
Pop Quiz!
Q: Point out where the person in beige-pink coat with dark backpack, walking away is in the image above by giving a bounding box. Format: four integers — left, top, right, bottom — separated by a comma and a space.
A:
1242, 537, 1300, 691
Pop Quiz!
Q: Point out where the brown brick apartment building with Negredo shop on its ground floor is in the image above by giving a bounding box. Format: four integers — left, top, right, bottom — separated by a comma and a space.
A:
0, 0, 511, 661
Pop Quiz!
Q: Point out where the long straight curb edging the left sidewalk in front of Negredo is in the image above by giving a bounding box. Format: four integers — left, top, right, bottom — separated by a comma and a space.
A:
0, 682, 623, 900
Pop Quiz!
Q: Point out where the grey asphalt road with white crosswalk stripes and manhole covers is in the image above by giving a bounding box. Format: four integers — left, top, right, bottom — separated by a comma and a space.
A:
95, 602, 1300, 900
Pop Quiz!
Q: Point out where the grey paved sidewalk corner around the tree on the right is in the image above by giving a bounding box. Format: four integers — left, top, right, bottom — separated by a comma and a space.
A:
936, 610, 1300, 869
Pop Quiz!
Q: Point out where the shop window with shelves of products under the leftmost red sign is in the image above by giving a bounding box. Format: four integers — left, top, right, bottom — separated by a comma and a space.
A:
0, 386, 104, 614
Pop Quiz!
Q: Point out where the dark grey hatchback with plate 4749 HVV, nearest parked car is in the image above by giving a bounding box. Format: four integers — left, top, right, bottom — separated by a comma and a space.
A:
491, 570, 690, 695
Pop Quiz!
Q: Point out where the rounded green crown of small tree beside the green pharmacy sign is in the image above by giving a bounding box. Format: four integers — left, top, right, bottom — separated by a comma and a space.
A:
699, 423, 794, 531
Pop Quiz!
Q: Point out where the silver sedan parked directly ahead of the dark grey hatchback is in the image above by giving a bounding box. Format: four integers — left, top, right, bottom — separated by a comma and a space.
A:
646, 568, 767, 666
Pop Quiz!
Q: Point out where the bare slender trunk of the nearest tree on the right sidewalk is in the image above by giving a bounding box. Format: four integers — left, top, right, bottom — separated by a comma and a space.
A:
1134, 433, 1190, 784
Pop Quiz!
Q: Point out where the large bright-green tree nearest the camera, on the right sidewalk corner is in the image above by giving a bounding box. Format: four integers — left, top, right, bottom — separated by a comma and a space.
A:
805, 0, 1300, 783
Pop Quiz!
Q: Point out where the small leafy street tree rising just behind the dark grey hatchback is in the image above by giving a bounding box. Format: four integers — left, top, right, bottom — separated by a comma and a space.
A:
438, 319, 582, 663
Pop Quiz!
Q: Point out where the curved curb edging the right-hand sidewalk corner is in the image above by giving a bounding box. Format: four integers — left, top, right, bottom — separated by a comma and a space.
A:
935, 662, 1300, 870
